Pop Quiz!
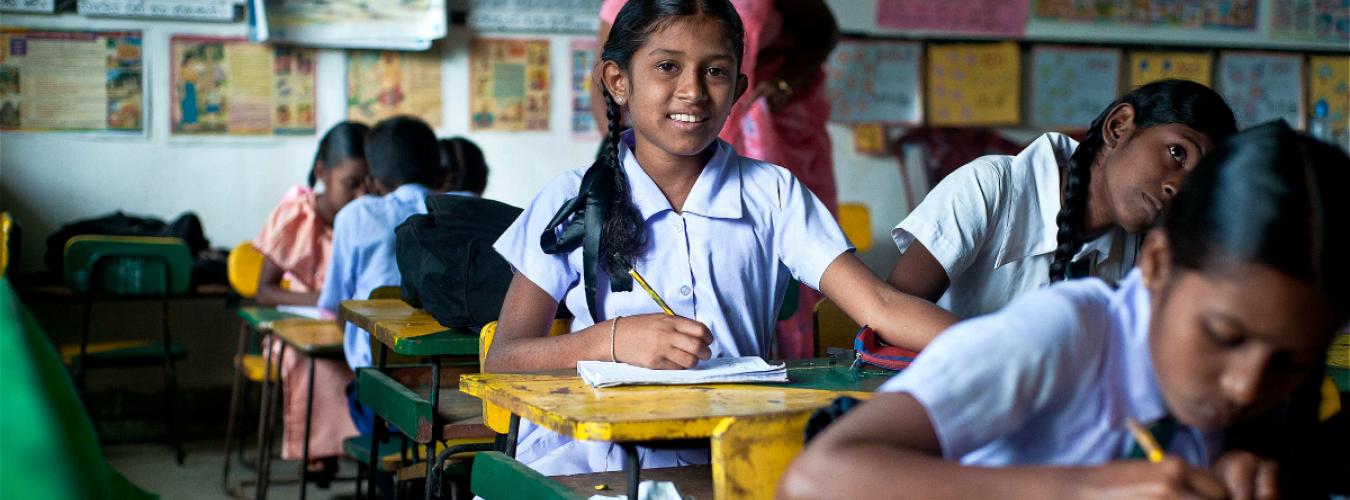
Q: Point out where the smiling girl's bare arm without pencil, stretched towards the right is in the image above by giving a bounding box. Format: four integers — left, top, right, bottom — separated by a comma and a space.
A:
821, 251, 957, 351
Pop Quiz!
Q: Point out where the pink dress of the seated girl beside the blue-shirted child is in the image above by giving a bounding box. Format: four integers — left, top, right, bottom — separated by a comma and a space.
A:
252, 186, 356, 459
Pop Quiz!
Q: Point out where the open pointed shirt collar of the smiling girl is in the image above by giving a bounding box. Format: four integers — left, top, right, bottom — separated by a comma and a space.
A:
618, 130, 743, 220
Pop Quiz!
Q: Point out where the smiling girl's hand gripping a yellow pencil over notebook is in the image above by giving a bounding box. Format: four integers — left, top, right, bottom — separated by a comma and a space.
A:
614, 314, 713, 370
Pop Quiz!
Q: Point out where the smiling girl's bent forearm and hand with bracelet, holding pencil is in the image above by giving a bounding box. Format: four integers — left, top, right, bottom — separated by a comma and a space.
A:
483, 273, 713, 372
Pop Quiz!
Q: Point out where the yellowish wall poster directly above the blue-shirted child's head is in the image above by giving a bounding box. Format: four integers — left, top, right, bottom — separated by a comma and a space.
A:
347, 50, 441, 128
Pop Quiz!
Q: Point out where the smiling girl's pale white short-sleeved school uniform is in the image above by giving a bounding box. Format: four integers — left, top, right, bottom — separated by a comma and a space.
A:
494, 131, 852, 474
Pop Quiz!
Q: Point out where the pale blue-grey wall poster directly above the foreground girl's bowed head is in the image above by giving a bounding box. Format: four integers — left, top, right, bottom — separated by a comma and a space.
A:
1218, 51, 1303, 128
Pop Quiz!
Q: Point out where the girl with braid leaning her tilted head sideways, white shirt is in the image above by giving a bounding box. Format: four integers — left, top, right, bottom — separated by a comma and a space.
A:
883, 80, 1237, 329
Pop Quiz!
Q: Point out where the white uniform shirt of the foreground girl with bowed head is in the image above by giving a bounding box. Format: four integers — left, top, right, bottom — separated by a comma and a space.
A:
880, 272, 1222, 468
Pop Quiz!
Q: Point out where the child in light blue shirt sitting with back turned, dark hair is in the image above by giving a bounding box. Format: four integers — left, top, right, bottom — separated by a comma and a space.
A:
319, 116, 443, 435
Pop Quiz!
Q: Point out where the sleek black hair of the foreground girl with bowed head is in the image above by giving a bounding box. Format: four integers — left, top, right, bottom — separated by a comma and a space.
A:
1162, 120, 1350, 316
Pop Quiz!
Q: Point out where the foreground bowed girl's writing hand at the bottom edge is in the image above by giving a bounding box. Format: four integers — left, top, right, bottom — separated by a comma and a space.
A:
1075, 457, 1229, 499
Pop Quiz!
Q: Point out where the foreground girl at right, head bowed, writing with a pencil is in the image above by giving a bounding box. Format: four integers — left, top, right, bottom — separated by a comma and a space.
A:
780, 123, 1350, 499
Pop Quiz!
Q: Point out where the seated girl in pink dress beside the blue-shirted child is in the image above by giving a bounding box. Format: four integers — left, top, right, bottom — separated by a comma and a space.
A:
252, 122, 370, 485
